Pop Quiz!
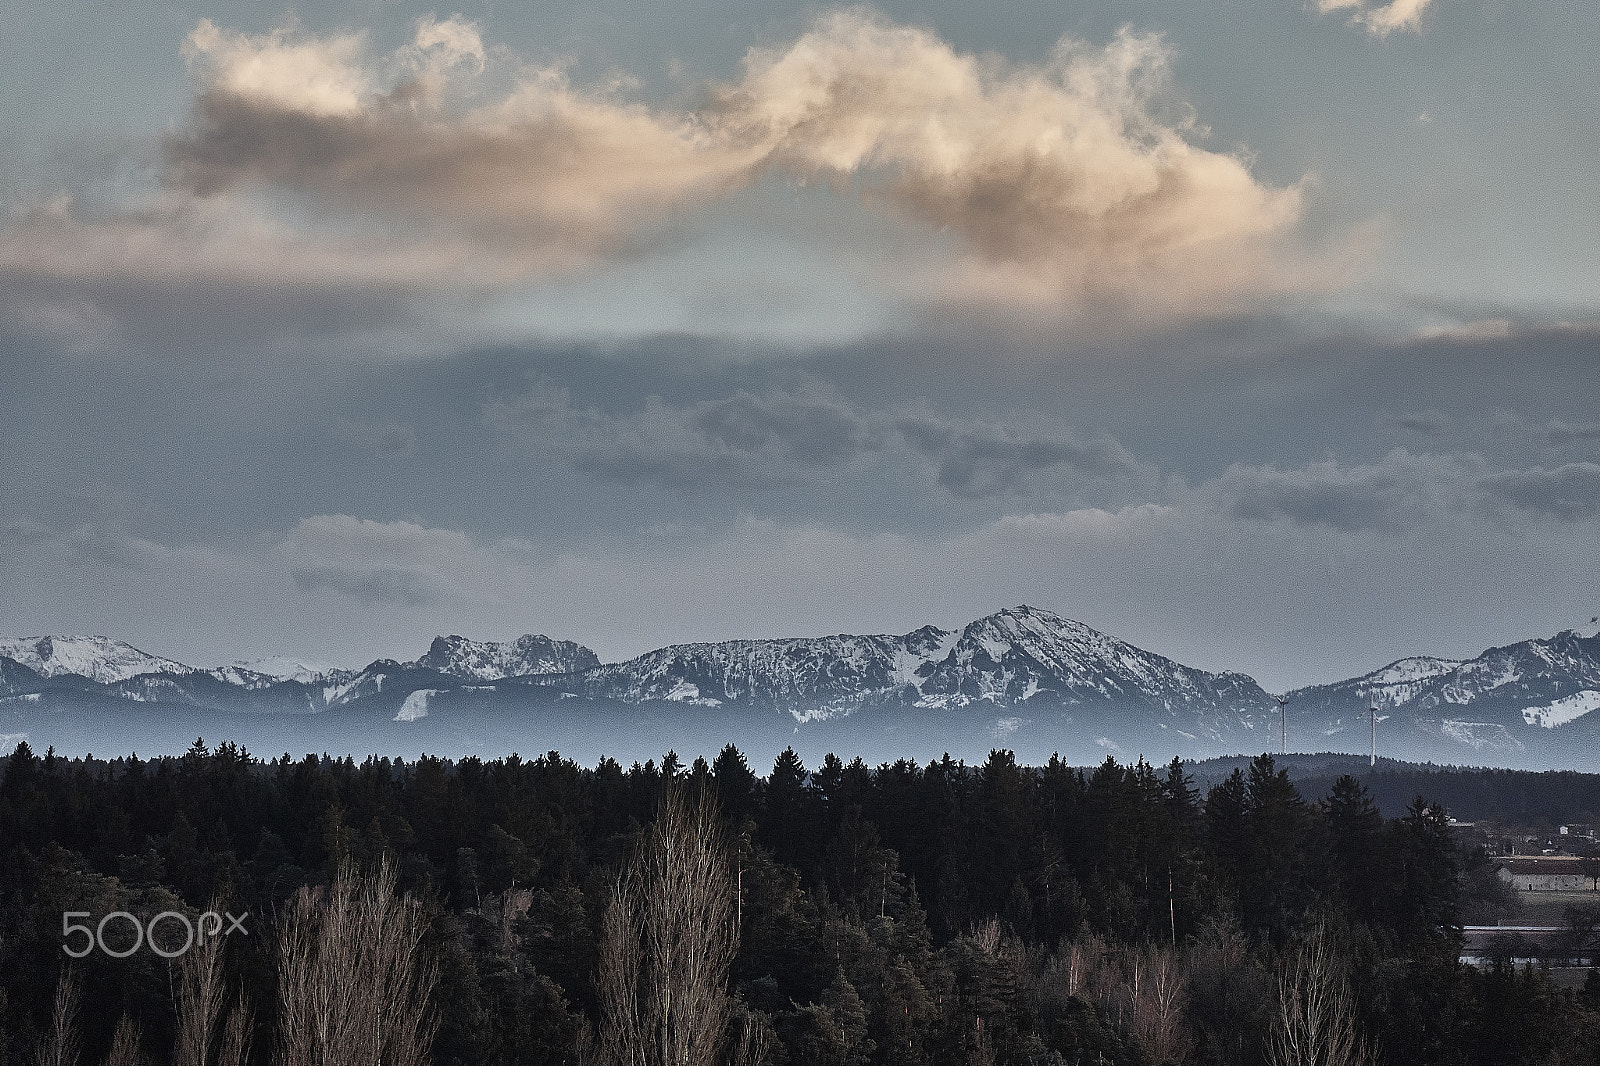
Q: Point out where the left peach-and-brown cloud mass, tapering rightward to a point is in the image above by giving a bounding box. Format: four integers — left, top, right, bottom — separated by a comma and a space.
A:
166, 21, 760, 264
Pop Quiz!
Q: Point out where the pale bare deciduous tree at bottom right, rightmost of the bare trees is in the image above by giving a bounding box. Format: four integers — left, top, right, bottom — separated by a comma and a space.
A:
1267, 925, 1368, 1066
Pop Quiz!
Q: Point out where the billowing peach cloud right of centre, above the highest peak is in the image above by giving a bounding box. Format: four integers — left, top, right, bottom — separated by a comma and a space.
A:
720, 11, 1306, 306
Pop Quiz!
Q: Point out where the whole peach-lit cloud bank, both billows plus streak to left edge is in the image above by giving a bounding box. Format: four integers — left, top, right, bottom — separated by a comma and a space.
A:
0, 11, 1330, 347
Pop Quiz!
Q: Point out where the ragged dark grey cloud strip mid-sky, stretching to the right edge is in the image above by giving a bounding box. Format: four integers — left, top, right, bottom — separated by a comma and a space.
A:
483, 377, 1600, 518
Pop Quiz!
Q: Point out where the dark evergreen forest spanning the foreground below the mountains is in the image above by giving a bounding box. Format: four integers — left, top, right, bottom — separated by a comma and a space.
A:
0, 743, 1600, 1066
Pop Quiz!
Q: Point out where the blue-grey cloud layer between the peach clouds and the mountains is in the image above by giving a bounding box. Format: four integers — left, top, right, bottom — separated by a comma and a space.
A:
0, 294, 1600, 685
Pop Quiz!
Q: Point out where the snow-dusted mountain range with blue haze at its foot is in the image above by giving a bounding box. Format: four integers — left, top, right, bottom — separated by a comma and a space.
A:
0, 607, 1600, 768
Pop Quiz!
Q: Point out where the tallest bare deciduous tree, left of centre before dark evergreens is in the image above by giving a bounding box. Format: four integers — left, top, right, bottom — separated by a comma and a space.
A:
595, 789, 739, 1066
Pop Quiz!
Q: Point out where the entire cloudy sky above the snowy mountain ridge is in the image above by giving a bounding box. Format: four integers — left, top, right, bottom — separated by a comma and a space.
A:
0, 0, 1600, 690
